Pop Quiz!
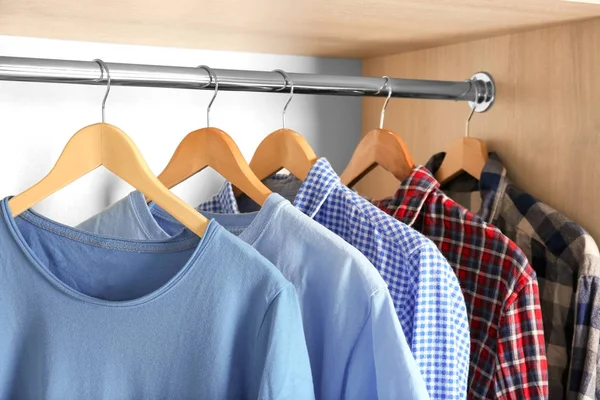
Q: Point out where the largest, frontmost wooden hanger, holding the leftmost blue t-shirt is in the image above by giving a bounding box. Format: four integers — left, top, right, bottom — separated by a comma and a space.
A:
8, 60, 208, 236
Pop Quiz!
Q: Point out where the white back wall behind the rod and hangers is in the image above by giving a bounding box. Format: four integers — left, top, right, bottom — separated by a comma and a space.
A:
0, 36, 362, 224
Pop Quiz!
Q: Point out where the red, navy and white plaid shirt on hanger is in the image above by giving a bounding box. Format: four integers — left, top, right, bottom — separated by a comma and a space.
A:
374, 167, 548, 400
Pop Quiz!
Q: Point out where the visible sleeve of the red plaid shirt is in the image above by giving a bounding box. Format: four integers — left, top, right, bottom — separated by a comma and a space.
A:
495, 277, 548, 400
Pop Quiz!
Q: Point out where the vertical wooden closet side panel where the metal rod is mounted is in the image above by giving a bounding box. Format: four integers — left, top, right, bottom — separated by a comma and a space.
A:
356, 19, 600, 240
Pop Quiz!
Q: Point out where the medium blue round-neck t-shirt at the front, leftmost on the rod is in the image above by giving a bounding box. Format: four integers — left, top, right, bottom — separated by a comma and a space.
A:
0, 199, 314, 400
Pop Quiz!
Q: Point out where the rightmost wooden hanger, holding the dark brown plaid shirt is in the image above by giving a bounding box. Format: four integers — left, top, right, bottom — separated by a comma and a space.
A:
435, 80, 488, 184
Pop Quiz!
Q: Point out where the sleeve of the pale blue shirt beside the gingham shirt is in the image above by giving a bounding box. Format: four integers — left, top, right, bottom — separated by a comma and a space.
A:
344, 288, 429, 400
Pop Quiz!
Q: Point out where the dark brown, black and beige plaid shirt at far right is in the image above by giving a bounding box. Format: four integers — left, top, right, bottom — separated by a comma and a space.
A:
427, 153, 600, 400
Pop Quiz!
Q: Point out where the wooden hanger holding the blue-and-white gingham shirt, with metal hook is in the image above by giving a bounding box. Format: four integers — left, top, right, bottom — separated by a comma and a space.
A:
250, 69, 317, 181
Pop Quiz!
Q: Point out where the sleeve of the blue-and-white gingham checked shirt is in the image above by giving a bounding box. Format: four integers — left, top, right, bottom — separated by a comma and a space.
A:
410, 243, 471, 400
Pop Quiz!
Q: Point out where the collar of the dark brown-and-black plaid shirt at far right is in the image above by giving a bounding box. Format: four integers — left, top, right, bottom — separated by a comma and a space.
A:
426, 153, 511, 224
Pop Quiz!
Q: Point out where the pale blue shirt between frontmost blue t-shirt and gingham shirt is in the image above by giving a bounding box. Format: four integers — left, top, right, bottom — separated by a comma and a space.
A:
79, 192, 429, 400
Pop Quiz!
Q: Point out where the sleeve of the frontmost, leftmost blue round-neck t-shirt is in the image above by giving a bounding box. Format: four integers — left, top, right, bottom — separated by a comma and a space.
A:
253, 284, 315, 400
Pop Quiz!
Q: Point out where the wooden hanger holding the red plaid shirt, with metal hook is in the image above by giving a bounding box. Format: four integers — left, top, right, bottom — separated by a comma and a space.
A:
340, 76, 415, 187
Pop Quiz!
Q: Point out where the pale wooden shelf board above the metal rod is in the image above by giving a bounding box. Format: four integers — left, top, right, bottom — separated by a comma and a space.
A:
0, 0, 600, 57
